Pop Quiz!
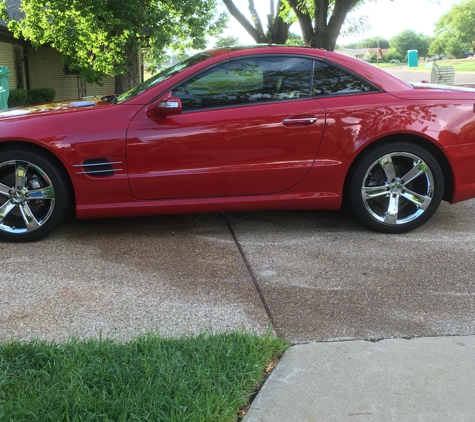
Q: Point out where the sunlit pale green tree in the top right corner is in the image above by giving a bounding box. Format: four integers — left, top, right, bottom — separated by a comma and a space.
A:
430, 0, 475, 56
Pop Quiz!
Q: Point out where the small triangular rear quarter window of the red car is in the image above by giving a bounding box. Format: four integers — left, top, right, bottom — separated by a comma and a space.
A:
312, 62, 373, 95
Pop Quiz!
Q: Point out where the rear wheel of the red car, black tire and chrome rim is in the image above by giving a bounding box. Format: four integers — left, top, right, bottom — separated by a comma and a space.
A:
347, 142, 444, 233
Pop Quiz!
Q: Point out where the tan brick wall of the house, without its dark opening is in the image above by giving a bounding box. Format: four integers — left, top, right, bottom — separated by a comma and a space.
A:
28, 47, 115, 101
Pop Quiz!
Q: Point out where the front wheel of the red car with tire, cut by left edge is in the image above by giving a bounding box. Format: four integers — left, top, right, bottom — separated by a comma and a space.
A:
0, 147, 70, 242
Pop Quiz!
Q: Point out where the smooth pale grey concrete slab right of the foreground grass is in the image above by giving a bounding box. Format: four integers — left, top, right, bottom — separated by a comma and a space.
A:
243, 336, 475, 422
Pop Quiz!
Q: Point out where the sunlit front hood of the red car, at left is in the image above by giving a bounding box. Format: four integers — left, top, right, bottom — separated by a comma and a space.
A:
0, 97, 111, 120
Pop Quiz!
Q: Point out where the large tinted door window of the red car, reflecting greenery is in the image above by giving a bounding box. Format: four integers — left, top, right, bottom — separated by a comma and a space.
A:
172, 57, 312, 110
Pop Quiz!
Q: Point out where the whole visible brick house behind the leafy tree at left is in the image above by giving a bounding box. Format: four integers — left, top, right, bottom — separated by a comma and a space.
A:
0, 0, 114, 101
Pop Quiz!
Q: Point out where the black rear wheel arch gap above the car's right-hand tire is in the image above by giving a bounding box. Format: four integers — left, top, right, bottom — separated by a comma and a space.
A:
343, 134, 454, 202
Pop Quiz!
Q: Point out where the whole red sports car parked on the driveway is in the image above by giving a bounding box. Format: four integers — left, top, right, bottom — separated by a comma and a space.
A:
0, 46, 475, 241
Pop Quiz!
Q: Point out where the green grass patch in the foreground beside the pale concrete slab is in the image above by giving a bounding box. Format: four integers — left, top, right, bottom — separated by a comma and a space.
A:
0, 333, 287, 422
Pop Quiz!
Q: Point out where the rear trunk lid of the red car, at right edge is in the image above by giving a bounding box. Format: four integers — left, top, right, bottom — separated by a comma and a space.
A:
391, 82, 475, 100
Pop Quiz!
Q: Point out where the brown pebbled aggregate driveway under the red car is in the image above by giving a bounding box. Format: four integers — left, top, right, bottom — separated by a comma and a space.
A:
0, 200, 475, 343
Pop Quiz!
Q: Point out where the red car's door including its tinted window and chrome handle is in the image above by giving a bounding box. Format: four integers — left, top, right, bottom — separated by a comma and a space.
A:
127, 56, 325, 199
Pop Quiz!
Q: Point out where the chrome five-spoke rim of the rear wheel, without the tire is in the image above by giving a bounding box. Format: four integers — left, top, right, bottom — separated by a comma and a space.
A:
361, 152, 434, 224
